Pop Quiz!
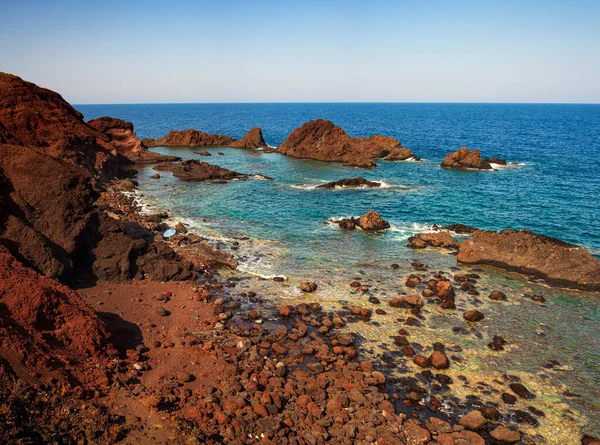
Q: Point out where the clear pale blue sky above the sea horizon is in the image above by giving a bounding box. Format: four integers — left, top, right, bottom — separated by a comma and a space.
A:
0, 0, 600, 104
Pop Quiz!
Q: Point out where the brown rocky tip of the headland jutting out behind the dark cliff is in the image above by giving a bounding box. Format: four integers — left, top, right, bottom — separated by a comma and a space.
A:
88, 116, 181, 164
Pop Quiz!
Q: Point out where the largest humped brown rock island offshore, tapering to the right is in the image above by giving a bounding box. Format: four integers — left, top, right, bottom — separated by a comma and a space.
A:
278, 119, 417, 168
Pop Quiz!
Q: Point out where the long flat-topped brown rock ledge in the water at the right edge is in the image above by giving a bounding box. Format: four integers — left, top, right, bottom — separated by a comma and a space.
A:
457, 229, 600, 292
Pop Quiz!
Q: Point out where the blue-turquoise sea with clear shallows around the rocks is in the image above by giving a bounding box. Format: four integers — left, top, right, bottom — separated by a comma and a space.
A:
76, 103, 600, 444
